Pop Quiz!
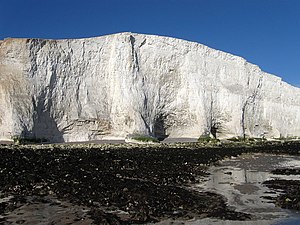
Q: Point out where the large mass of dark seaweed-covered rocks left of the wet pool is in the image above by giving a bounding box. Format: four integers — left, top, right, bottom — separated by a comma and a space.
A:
0, 147, 249, 224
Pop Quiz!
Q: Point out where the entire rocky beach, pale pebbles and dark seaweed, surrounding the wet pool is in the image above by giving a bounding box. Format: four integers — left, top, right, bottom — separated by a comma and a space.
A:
0, 142, 300, 224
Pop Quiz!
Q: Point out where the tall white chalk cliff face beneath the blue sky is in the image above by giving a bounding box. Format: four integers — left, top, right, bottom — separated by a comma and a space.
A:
0, 33, 300, 141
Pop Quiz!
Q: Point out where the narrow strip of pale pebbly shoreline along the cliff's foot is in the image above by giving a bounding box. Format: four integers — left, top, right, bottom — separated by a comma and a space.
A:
0, 140, 300, 155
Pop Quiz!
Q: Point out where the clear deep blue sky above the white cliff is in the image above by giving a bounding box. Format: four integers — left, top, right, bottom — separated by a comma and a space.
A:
0, 0, 300, 87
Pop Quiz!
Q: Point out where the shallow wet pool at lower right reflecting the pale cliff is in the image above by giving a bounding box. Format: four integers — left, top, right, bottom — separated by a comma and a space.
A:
198, 154, 300, 224
